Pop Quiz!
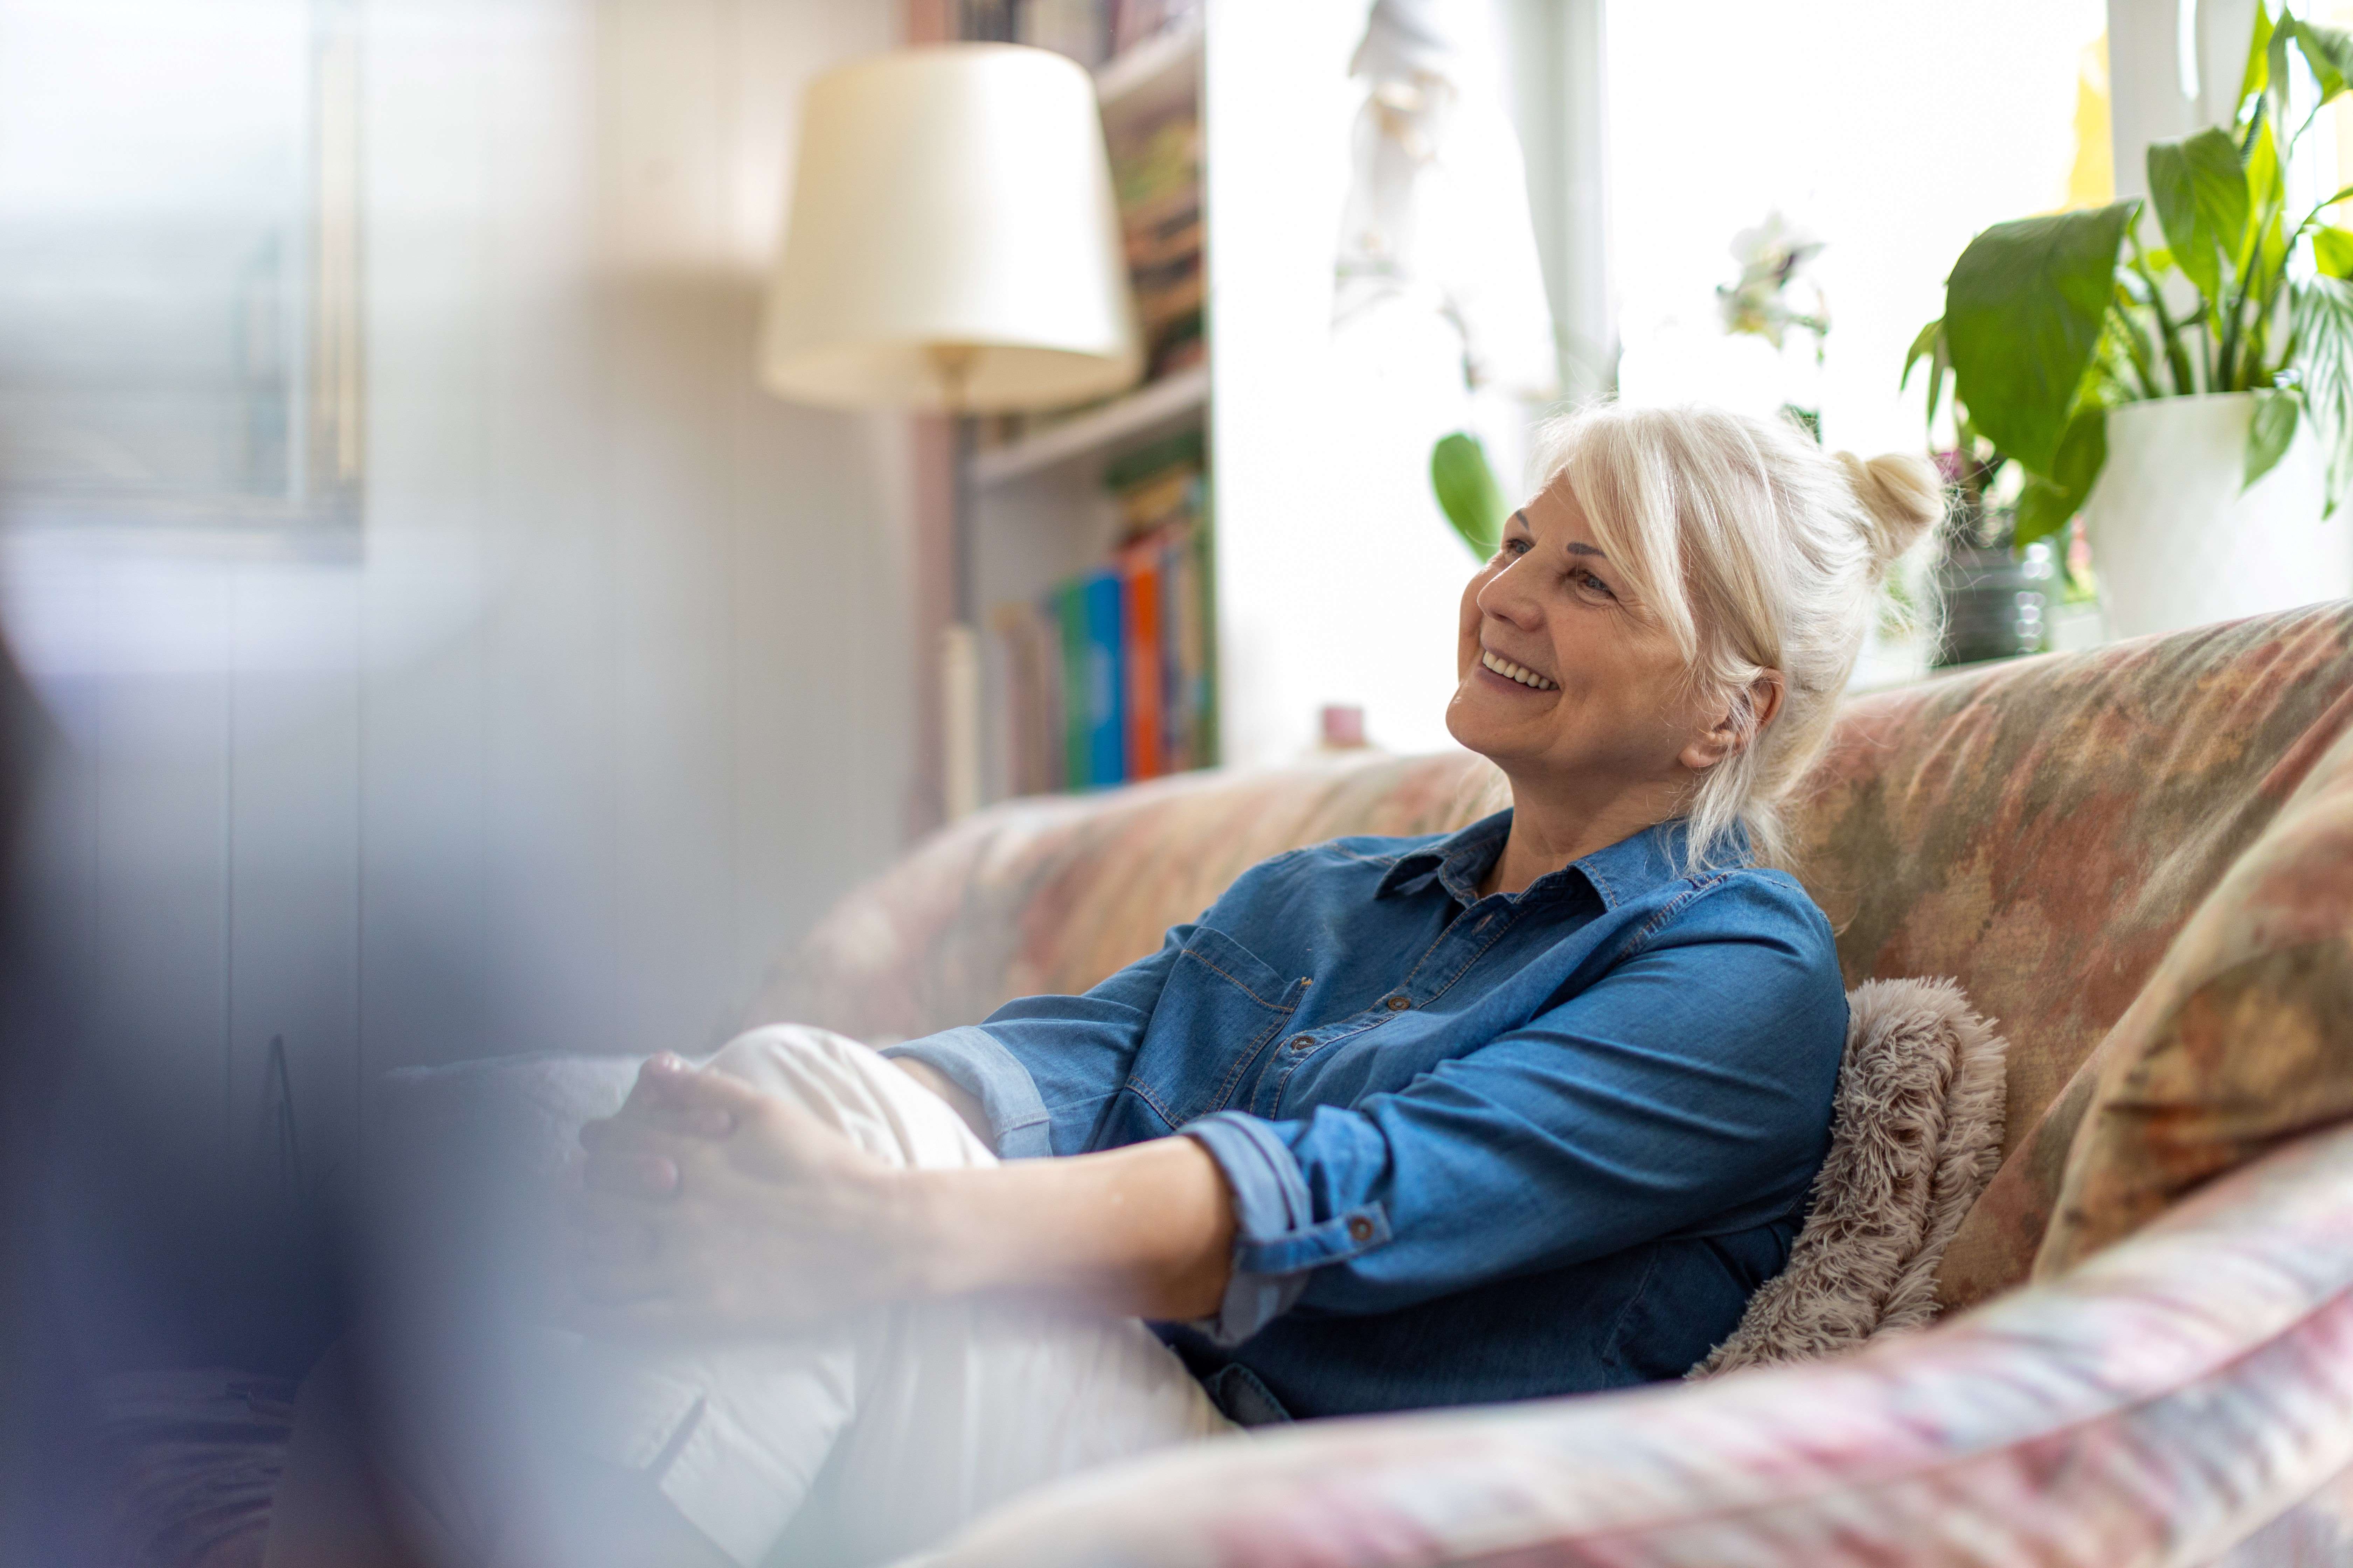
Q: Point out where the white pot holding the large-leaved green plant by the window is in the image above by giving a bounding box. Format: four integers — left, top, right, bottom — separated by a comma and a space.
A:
2082, 392, 2353, 637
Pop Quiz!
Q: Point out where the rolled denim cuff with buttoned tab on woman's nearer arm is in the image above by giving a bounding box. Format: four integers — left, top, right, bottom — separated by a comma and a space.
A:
1176, 1110, 1391, 1345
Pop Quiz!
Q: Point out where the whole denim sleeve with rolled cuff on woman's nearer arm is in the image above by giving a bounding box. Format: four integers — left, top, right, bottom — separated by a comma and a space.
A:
1181, 888, 1847, 1345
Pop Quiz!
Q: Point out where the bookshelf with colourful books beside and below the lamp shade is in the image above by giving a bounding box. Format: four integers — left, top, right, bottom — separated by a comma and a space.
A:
970, 7, 1216, 802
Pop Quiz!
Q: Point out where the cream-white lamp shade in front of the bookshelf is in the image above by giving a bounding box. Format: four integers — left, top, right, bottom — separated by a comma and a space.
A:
760, 45, 1144, 414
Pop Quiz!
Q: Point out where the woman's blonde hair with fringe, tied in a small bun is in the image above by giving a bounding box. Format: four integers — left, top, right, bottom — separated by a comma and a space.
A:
1536, 404, 1944, 867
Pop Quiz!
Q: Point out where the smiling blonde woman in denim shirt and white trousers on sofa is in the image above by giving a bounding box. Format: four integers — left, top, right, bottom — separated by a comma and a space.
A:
278, 409, 1939, 1568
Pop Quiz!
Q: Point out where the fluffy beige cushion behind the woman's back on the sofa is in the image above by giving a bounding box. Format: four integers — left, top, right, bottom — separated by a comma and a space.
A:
1692, 980, 2007, 1378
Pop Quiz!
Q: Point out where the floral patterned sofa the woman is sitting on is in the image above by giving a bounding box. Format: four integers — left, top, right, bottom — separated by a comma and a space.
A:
748, 604, 2353, 1568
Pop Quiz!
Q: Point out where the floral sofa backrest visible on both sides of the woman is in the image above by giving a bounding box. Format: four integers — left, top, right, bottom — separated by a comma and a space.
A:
751, 602, 2353, 1279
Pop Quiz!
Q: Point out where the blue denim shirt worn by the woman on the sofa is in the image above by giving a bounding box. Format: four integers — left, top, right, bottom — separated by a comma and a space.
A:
889, 811, 1847, 1420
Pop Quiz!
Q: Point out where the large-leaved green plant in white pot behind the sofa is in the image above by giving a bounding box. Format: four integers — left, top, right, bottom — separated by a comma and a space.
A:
1903, 2, 2353, 635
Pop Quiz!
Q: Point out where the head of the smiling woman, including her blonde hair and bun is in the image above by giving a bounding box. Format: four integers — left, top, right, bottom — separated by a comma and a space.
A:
1447, 407, 1944, 893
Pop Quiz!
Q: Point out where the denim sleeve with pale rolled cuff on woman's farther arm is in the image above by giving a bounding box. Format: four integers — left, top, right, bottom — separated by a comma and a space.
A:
882, 924, 1193, 1159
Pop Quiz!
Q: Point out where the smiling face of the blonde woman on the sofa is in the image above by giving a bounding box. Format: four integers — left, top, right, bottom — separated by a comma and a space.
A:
1447, 482, 1722, 799
